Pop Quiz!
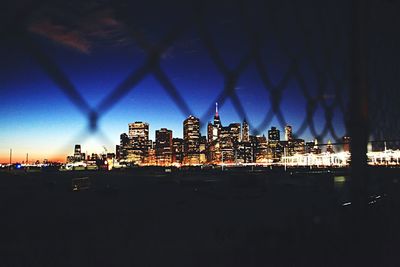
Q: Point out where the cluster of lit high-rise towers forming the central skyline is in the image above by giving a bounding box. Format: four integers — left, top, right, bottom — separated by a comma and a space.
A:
105, 104, 349, 166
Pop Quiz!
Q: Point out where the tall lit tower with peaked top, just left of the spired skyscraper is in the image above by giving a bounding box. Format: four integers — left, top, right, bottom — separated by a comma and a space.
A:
183, 115, 200, 165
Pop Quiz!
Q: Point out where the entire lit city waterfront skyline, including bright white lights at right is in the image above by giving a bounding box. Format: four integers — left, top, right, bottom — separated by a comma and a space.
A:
57, 103, 400, 170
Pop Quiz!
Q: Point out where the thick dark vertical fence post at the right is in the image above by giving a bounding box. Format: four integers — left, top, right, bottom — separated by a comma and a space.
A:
348, 0, 369, 238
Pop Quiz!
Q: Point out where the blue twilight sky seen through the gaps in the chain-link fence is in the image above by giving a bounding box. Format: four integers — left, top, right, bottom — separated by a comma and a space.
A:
0, 1, 346, 161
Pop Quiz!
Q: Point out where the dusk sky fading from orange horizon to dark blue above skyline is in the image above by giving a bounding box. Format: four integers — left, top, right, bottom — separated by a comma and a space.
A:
0, 1, 356, 162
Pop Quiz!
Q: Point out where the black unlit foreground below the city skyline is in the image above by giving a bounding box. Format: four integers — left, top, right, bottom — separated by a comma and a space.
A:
0, 169, 400, 266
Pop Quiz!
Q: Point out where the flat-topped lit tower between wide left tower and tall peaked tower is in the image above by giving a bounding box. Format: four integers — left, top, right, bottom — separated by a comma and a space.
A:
155, 128, 172, 166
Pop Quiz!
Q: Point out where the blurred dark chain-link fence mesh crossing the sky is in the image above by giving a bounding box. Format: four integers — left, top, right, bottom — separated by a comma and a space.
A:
3, 1, 399, 158
